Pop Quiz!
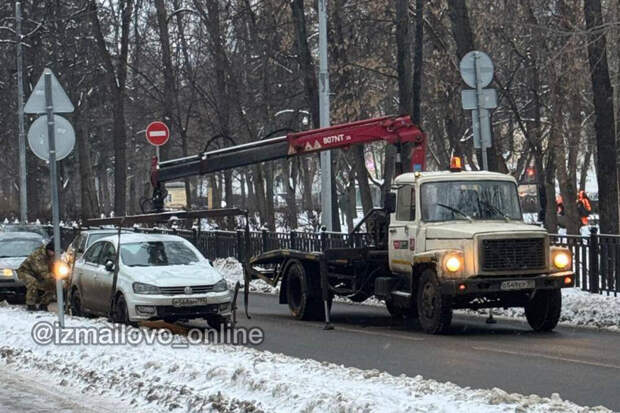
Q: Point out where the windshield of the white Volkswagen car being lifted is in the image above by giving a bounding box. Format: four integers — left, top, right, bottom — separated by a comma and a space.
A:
121, 241, 198, 267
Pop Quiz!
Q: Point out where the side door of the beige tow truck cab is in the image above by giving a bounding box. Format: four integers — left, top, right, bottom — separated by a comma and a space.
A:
389, 184, 416, 274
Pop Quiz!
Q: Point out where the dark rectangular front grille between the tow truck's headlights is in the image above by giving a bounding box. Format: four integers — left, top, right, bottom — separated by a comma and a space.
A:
481, 238, 547, 271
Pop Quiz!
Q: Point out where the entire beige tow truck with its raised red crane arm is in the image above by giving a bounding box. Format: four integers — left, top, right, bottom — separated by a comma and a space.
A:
151, 116, 574, 334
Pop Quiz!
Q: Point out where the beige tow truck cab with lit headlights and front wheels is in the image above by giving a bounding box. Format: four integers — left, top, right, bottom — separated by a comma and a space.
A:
386, 170, 574, 333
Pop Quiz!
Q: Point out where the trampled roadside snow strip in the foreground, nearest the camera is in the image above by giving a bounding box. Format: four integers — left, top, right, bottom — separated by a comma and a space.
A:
0, 307, 609, 412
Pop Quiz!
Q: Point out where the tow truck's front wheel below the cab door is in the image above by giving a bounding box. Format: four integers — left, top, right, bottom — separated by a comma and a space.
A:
417, 269, 452, 334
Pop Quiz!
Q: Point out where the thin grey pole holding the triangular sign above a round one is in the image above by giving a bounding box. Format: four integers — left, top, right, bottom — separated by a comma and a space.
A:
45, 71, 65, 328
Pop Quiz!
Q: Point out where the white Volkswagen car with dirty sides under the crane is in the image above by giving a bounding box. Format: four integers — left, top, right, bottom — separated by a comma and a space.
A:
71, 234, 232, 328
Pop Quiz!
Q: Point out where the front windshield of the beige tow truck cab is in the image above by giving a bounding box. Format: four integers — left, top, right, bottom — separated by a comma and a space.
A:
420, 181, 521, 222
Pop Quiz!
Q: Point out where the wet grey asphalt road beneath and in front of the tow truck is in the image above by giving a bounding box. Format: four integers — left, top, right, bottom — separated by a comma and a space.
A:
238, 294, 620, 411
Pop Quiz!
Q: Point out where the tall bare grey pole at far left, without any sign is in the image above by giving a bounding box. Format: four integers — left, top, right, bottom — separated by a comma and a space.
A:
15, 2, 28, 223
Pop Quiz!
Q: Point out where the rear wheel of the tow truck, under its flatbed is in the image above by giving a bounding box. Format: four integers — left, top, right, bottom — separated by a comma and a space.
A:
286, 261, 324, 320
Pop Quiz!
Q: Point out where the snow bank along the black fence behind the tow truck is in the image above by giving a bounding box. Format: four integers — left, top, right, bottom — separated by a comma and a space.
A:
215, 258, 620, 331
